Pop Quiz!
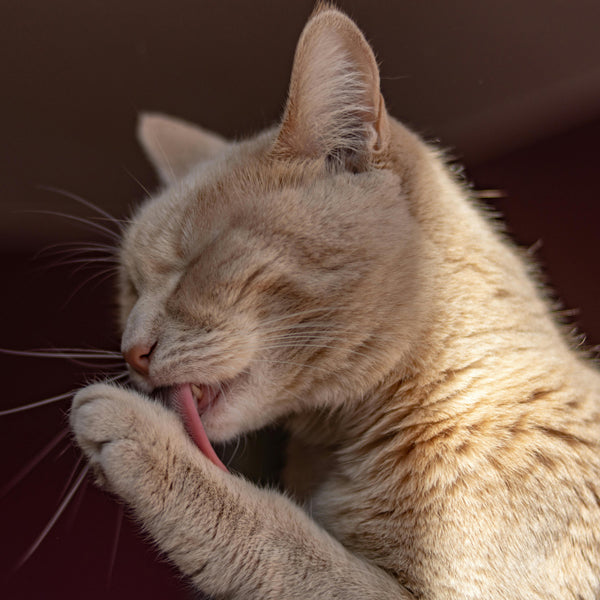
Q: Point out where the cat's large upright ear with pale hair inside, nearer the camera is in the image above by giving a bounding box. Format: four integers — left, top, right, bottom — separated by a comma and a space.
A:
274, 8, 389, 170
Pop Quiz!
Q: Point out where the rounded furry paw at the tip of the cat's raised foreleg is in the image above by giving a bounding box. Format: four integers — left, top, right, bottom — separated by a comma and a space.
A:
70, 384, 185, 501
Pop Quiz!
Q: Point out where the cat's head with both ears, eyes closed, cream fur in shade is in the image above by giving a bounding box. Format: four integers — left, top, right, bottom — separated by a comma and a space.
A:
120, 8, 419, 441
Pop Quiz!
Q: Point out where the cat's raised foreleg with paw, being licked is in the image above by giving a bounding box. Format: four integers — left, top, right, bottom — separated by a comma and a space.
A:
70, 384, 412, 600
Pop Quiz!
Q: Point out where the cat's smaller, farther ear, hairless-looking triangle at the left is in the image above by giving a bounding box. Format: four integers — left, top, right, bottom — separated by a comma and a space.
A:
137, 113, 227, 183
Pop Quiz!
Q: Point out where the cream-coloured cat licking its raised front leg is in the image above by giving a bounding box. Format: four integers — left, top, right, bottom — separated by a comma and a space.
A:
70, 5, 600, 600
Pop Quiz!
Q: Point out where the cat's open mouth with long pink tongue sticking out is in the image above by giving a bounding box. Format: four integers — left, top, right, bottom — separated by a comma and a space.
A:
171, 383, 228, 473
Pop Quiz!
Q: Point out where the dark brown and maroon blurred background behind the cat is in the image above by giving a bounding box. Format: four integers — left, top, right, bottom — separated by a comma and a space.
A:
0, 0, 600, 600
